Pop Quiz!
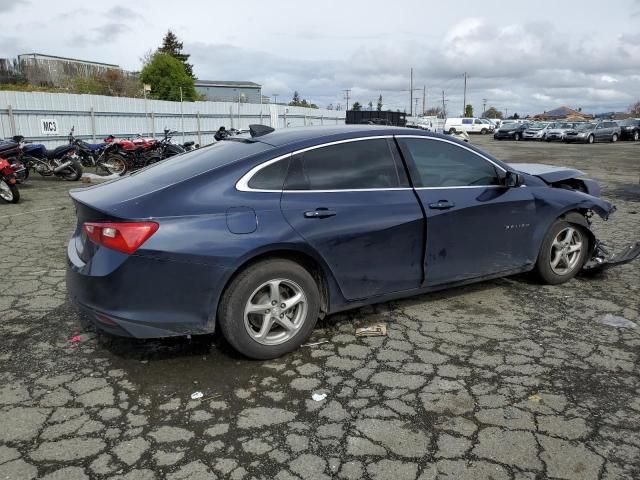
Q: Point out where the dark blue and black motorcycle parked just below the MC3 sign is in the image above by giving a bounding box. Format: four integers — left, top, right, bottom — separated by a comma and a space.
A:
22, 132, 82, 182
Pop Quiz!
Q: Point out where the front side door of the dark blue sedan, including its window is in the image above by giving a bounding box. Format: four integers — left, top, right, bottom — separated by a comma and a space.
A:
396, 136, 537, 286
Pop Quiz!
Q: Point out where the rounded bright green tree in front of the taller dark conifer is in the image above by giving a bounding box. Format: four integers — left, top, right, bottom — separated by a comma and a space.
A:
140, 53, 198, 102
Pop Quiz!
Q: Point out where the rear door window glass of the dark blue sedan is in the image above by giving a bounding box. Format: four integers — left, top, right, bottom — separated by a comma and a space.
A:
285, 139, 400, 190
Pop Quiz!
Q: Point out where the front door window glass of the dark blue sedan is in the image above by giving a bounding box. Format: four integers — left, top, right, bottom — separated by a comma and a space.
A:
400, 138, 500, 187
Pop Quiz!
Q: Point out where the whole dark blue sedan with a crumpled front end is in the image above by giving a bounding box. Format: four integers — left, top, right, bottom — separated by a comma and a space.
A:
67, 126, 639, 359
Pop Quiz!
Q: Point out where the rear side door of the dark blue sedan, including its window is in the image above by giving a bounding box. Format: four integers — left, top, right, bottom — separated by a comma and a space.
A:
281, 137, 424, 300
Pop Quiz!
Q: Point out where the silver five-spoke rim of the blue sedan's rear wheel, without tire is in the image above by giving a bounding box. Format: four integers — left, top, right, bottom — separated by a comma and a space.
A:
244, 278, 308, 345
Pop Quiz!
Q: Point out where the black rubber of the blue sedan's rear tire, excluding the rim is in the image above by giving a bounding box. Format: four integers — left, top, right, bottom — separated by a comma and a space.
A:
218, 259, 320, 360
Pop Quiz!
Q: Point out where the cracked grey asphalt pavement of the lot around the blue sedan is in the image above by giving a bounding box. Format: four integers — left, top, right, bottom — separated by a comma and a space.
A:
0, 137, 640, 480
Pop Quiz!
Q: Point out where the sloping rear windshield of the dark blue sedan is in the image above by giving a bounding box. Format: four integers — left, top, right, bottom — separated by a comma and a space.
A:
123, 140, 273, 185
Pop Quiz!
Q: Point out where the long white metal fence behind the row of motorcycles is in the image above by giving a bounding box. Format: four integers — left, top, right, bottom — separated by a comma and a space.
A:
0, 91, 345, 146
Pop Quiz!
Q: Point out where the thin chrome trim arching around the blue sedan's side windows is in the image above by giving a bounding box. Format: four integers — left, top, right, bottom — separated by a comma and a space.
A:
236, 135, 507, 193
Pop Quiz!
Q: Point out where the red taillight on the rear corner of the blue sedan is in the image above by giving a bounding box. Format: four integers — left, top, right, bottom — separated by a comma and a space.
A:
83, 222, 159, 255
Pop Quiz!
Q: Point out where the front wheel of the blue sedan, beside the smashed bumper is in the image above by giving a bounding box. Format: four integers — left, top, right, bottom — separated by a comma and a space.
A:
535, 220, 589, 285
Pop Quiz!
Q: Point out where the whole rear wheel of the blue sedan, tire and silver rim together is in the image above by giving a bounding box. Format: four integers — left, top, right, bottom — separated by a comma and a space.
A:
218, 259, 320, 360
